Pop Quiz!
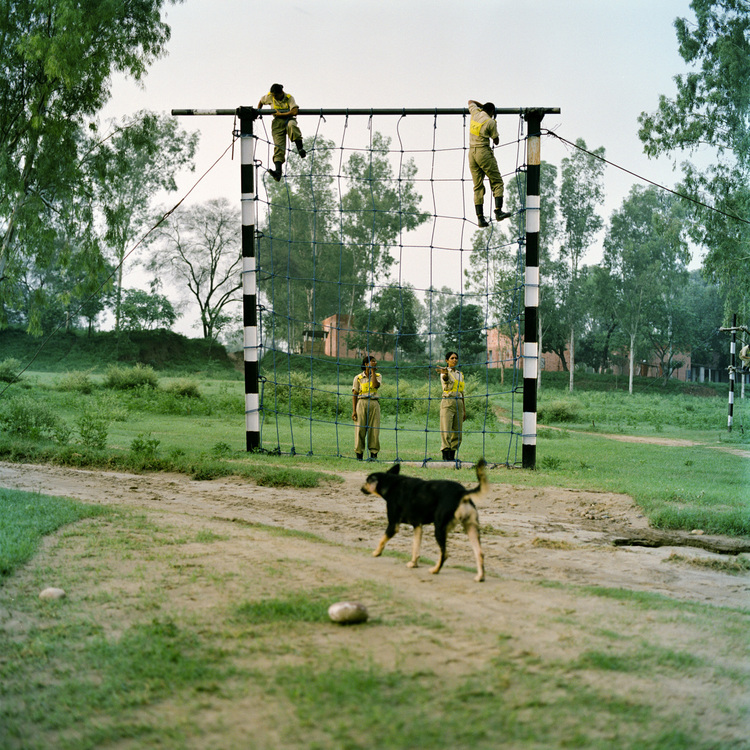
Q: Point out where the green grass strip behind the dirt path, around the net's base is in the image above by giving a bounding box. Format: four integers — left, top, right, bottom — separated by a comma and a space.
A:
0, 350, 750, 536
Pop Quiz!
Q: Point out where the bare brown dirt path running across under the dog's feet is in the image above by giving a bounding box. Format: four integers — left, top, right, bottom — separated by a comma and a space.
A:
0, 463, 750, 607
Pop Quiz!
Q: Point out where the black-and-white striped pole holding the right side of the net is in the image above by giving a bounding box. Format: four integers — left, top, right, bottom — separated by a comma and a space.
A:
521, 109, 544, 469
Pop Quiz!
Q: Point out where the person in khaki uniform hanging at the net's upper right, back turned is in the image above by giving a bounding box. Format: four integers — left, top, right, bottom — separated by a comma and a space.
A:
469, 99, 510, 227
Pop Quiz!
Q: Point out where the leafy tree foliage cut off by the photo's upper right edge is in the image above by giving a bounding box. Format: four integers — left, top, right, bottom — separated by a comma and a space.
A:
639, 0, 750, 317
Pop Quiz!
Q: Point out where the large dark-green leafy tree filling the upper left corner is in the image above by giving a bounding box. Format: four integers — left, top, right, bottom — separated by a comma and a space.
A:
0, 0, 178, 297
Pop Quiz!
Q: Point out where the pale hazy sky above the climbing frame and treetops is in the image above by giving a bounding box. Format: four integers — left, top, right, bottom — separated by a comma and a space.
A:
102, 0, 694, 335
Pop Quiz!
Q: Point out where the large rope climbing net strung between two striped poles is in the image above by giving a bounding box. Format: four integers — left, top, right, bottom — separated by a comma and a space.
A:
254, 114, 525, 466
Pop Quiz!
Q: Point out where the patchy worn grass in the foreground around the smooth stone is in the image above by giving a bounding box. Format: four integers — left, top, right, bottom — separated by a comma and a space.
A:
0, 512, 750, 750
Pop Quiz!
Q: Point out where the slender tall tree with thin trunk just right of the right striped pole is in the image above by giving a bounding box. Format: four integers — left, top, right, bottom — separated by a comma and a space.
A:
560, 138, 604, 392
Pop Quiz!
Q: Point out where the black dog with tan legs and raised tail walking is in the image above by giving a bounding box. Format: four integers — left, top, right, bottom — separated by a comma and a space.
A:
362, 459, 489, 582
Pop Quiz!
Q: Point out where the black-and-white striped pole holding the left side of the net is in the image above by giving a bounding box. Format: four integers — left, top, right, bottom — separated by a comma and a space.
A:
237, 107, 260, 451
